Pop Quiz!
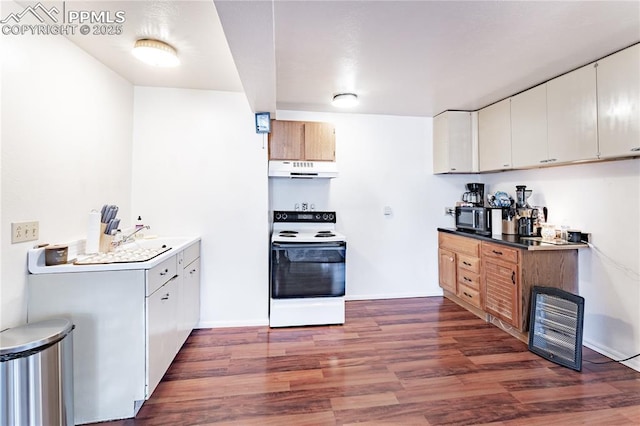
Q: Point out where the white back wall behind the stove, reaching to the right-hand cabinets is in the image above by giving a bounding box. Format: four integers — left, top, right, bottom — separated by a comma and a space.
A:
270, 111, 465, 299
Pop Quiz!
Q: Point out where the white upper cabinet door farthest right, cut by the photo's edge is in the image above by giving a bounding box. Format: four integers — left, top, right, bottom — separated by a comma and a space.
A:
596, 44, 640, 158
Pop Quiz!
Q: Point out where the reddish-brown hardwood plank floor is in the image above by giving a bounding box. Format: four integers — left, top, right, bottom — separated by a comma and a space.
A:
94, 297, 640, 426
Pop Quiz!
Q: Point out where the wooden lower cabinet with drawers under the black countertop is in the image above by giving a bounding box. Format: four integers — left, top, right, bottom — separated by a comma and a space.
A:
438, 232, 578, 340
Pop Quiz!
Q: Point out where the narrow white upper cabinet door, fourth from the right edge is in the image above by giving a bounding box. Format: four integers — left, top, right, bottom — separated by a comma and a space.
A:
478, 98, 511, 172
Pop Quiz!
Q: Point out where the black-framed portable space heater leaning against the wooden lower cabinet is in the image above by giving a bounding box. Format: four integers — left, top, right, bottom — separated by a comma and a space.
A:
529, 286, 584, 371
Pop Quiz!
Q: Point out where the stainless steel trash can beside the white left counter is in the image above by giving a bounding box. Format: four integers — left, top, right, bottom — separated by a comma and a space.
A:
0, 319, 74, 426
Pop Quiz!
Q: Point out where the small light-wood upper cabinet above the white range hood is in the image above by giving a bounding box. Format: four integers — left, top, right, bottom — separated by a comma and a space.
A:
269, 120, 336, 161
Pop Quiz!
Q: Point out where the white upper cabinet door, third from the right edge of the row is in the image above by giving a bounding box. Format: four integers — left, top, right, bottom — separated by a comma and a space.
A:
511, 84, 549, 168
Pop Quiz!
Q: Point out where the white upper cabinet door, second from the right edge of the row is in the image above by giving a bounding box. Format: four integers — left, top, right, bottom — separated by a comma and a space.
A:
547, 64, 598, 164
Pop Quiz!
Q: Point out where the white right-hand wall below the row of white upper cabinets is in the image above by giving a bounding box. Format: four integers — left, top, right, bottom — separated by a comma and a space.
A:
477, 159, 640, 371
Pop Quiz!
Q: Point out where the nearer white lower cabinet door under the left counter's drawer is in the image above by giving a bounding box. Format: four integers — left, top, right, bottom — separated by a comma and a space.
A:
146, 277, 178, 398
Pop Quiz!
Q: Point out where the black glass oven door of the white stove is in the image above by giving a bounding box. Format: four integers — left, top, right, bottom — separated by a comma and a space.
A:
271, 242, 347, 299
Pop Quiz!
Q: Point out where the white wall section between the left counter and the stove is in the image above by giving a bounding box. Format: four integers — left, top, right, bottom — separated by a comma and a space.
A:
132, 87, 269, 327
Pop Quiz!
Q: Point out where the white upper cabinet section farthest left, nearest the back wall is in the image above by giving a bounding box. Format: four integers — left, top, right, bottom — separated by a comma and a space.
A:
433, 111, 473, 174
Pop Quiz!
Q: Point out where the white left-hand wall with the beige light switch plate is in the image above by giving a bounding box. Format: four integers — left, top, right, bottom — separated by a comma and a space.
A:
0, 1, 133, 330
